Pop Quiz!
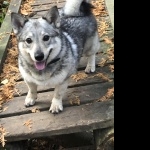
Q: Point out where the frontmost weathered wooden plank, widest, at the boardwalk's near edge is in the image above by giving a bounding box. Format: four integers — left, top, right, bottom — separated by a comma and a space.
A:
0, 100, 114, 141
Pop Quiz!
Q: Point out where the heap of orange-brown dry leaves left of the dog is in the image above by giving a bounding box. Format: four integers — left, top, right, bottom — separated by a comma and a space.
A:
0, 34, 19, 104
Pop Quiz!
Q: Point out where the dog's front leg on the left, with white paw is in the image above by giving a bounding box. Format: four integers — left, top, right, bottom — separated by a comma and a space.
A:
25, 81, 37, 106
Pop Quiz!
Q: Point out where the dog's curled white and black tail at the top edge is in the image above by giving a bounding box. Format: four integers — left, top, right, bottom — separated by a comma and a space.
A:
64, 0, 92, 16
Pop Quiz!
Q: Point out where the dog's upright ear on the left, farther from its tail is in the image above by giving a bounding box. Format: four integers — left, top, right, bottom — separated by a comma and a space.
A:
11, 12, 28, 34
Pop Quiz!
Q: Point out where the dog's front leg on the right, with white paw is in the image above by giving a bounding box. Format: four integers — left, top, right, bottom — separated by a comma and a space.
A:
49, 81, 68, 113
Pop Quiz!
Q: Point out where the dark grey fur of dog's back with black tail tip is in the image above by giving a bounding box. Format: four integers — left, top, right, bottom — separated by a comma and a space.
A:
61, 1, 97, 39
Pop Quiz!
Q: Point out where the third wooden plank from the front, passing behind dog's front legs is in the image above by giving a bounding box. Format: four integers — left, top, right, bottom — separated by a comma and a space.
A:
14, 66, 114, 96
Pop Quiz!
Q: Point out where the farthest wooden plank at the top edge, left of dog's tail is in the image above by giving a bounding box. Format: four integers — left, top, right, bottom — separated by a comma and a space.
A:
31, 0, 66, 6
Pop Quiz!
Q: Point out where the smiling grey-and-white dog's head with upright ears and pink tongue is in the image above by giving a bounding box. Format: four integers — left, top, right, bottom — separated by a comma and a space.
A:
11, 6, 61, 70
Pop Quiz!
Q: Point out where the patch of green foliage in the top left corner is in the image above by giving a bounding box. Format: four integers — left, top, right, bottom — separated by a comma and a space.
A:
0, 0, 9, 27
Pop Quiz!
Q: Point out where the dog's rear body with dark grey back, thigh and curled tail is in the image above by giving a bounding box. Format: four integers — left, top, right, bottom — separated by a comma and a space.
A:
61, 0, 100, 61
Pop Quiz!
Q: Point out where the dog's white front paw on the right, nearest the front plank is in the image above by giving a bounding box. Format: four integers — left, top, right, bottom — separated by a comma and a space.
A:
49, 98, 63, 113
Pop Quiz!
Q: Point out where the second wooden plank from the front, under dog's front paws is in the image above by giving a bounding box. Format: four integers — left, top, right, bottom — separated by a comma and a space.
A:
0, 82, 114, 118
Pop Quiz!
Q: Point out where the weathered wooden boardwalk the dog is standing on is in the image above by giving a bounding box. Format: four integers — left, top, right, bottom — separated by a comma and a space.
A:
0, 0, 114, 148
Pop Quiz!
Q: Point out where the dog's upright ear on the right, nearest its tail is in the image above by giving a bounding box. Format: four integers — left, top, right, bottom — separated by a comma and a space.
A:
43, 6, 60, 28
